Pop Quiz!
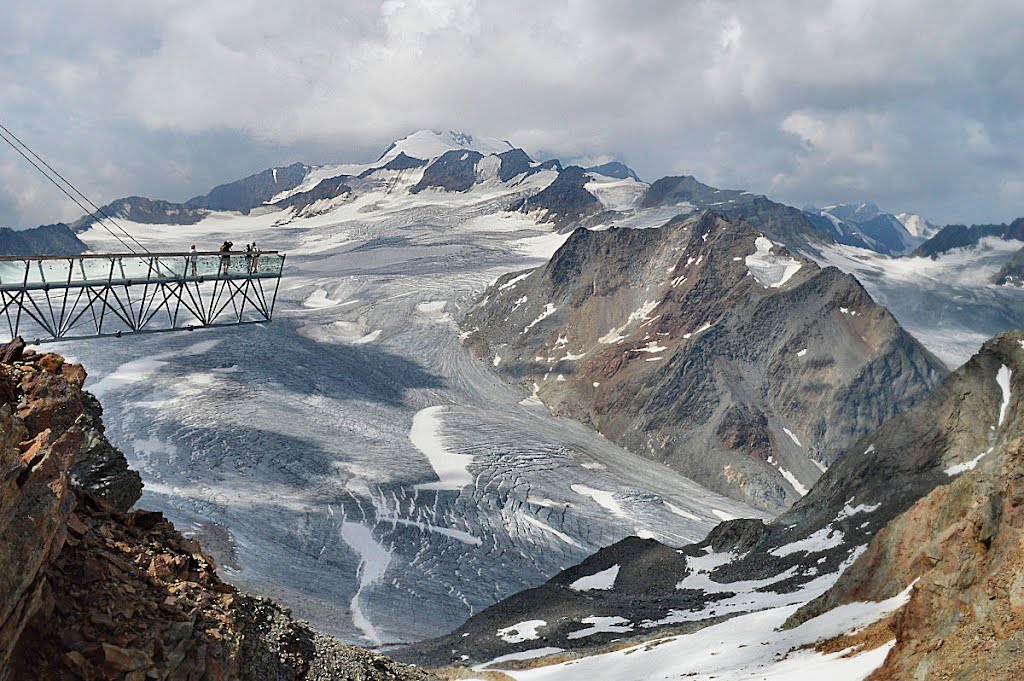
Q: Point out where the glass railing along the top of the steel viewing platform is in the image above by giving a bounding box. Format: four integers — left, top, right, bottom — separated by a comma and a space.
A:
0, 251, 285, 287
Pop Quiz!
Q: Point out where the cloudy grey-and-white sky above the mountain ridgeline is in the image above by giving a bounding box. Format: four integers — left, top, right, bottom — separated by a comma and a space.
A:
0, 0, 1024, 227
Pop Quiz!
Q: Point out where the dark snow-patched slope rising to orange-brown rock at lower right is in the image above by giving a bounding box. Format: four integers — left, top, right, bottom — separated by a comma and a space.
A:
398, 331, 1024, 679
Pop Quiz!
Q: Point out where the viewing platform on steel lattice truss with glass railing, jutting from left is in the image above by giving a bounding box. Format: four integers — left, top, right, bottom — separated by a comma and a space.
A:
0, 251, 285, 342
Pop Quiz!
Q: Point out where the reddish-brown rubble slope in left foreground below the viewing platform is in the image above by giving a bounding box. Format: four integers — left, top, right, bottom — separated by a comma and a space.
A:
0, 339, 427, 681
